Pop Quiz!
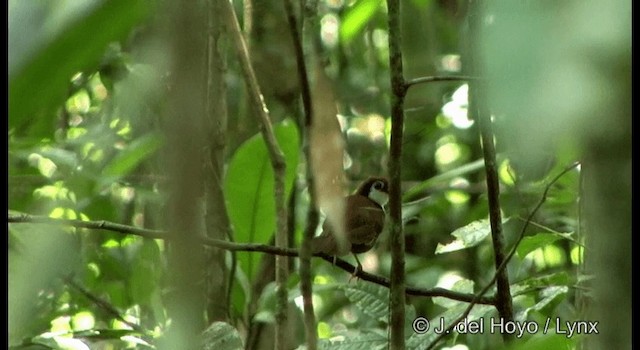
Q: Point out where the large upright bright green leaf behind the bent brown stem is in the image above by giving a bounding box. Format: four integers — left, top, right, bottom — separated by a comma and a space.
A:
224, 120, 300, 279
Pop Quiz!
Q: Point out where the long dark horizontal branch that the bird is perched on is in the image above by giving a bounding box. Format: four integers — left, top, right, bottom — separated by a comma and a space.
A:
8, 214, 495, 305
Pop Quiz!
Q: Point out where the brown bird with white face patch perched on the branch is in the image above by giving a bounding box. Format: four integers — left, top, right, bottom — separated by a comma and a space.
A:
311, 177, 389, 276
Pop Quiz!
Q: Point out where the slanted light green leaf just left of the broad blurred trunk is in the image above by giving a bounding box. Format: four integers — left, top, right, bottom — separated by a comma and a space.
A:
101, 132, 163, 184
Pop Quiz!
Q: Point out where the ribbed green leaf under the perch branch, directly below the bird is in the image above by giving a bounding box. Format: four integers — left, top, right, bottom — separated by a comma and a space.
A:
344, 281, 389, 322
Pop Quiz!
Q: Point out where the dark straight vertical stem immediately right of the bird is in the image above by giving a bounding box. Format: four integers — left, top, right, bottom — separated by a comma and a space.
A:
387, 0, 407, 349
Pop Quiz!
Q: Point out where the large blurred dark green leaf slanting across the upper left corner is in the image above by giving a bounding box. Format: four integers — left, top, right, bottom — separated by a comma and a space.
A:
9, 0, 153, 136
